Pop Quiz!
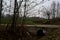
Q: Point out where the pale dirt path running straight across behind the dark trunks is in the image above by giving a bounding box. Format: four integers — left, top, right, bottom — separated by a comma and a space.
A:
1, 24, 60, 28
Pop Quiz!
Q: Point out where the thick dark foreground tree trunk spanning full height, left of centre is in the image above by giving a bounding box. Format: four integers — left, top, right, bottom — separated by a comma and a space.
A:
11, 0, 17, 40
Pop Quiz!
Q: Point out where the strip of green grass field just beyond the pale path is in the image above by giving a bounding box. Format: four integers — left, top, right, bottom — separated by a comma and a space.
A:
1, 17, 60, 25
